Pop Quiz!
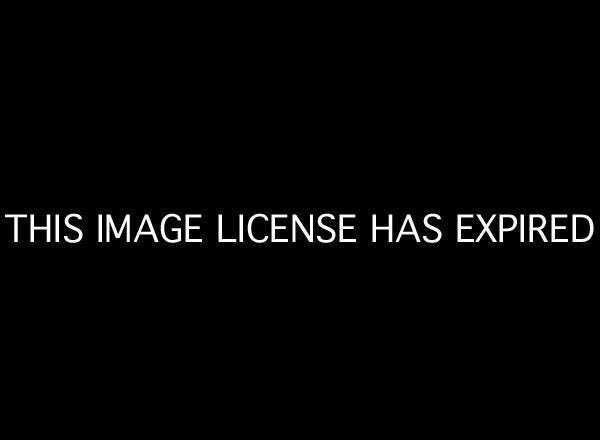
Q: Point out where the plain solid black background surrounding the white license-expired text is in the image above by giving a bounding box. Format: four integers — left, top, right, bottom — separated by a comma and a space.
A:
1, 5, 598, 433
